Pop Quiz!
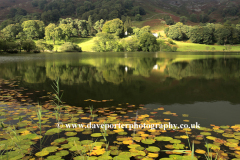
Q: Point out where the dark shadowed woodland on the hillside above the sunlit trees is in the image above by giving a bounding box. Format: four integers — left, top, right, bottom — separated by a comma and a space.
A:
32, 0, 146, 23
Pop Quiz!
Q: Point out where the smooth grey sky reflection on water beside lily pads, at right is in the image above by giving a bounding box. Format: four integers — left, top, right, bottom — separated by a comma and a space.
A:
144, 101, 240, 127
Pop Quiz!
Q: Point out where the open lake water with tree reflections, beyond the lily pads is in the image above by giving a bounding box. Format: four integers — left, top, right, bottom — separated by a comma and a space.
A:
0, 53, 240, 127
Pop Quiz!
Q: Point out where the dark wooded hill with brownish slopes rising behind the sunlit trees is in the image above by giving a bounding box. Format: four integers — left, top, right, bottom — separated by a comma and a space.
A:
0, 0, 240, 25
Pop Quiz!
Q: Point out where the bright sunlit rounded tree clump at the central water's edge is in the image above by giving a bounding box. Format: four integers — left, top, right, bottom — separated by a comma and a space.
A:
92, 19, 177, 52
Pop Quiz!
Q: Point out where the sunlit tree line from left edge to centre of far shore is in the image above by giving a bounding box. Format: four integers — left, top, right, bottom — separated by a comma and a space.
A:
0, 15, 177, 52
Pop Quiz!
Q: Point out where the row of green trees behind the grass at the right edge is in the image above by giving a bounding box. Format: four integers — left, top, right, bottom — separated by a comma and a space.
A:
165, 23, 240, 45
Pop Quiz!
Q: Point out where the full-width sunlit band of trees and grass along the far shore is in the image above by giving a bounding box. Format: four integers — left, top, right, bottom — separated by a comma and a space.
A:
0, 6, 240, 53
